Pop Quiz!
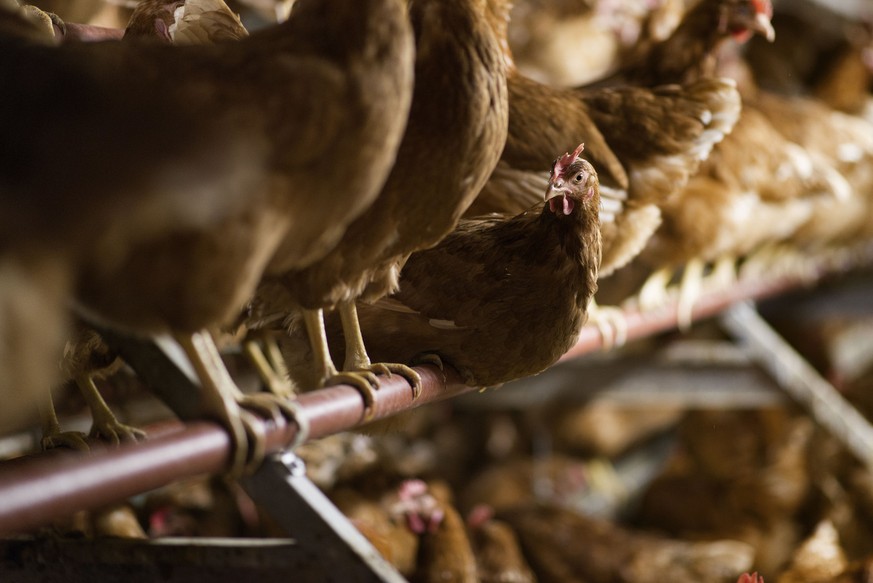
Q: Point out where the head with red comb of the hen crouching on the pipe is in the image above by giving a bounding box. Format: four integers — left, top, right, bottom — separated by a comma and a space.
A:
546, 144, 600, 215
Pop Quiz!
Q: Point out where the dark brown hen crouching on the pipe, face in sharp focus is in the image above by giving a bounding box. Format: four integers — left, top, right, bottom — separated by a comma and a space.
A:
284, 146, 600, 386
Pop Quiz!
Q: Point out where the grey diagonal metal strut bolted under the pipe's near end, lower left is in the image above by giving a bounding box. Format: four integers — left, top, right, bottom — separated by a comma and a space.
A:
241, 451, 406, 583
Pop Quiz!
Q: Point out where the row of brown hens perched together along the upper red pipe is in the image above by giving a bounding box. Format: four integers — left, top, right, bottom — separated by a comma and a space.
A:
0, 0, 873, 580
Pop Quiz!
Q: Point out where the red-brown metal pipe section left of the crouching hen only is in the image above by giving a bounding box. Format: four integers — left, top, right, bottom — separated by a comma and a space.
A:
0, 366, 474, 534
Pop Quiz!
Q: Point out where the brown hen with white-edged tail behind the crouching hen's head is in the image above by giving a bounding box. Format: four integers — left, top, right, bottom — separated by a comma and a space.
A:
467, 0, 739, 288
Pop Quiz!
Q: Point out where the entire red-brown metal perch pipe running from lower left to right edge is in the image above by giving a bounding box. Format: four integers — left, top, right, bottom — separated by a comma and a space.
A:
0, 244, 870, 534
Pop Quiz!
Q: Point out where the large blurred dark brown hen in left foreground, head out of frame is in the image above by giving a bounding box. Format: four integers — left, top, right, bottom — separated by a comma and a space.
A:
0, 0, 412, 470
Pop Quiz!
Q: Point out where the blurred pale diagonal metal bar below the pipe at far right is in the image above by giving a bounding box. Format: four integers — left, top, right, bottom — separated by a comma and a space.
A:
721, 302, 873, 468
